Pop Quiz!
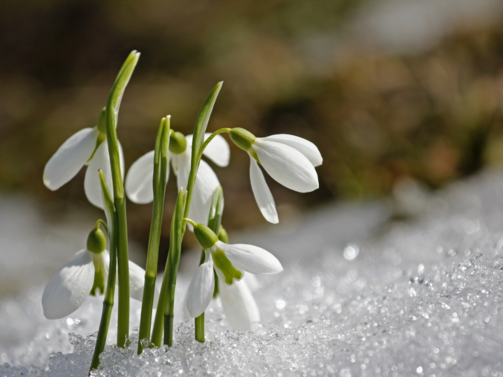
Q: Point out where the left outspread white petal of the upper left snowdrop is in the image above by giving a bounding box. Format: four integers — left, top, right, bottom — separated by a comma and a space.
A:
44, 127, 99, 190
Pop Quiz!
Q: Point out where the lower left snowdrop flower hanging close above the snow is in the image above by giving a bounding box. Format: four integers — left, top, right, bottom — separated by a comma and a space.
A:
42, 228, 149, 319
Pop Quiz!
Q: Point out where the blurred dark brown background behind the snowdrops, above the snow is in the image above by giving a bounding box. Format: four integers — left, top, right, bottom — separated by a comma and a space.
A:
0, 0, 503, 253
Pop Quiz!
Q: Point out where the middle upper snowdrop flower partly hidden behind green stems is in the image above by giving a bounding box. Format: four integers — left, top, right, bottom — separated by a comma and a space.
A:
126, 131, 230, 224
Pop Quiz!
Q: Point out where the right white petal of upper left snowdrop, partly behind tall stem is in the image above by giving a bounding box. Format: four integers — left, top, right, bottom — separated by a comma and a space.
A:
84, 140, 124, 209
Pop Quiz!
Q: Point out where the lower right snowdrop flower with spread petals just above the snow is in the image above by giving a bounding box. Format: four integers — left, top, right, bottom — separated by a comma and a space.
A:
187, 220, 283, 320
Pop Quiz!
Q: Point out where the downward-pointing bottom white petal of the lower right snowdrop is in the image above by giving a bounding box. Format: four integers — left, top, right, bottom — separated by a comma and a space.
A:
218, 270, 260, 331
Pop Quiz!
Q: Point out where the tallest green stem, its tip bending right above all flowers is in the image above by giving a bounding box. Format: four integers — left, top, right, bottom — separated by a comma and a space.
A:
105, 51, 140, 347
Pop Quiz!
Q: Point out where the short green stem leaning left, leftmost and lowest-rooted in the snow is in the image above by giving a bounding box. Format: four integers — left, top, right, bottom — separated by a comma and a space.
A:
89, 171, 117, 373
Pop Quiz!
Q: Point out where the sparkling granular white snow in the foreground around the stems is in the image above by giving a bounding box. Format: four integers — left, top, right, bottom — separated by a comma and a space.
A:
0, 172, 503, 377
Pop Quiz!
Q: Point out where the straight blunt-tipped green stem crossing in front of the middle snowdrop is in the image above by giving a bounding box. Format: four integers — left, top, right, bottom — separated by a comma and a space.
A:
138, 117, 169, 354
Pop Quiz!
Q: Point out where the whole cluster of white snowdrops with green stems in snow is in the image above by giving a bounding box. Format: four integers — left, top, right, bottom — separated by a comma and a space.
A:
42, 51, 322, 370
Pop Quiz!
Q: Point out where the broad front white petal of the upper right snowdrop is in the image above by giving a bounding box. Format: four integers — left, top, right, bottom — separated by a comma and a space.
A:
253, 139, 319, 192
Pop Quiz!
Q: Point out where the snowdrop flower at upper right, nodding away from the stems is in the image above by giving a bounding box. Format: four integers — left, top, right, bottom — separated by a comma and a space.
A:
229, 128, 323, 224
